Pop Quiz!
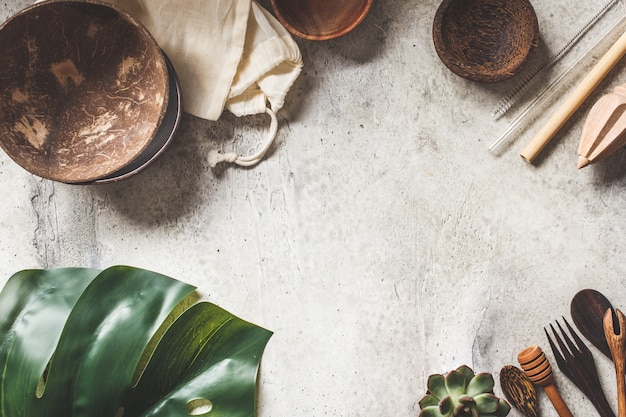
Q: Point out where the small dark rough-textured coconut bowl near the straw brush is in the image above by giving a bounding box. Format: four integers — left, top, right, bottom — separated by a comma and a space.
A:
433, 0, 539, 82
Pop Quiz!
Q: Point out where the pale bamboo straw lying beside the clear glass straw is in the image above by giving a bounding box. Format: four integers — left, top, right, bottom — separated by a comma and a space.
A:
520, 28, 626, 163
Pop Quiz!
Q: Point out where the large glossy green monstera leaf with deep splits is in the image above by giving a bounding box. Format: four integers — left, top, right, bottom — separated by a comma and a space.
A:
0, 266, 272, 417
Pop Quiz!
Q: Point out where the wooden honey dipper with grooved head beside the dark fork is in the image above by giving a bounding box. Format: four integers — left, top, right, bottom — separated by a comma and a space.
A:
517, 346, 573, 417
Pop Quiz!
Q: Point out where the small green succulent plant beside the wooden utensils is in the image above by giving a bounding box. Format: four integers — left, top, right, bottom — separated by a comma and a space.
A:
419, 365, 511, 417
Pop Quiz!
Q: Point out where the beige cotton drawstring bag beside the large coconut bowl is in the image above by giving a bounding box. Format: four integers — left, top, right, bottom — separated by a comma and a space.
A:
108, 0, 302, 166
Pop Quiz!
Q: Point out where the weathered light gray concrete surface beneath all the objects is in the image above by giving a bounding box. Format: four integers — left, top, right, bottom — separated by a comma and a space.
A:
0, 0, 626, 417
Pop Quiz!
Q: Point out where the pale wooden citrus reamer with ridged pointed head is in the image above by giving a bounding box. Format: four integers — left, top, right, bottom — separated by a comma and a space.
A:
578, 85, 626, 169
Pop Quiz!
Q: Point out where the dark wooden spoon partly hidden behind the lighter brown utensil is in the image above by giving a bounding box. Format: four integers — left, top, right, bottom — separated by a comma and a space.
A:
570, 289, 613, 359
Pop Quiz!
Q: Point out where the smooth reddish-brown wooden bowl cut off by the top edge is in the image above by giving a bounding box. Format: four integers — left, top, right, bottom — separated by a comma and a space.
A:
272, 0, 373, 41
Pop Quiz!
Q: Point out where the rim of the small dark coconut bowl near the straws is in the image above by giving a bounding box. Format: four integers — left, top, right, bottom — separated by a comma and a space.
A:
432, 0, 540, 83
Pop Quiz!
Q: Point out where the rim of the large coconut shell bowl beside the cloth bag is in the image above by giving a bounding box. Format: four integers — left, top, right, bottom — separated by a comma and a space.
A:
0, 0, 171, 184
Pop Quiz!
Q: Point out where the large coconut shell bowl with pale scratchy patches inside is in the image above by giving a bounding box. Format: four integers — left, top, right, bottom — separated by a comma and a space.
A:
0, 0, 170, 183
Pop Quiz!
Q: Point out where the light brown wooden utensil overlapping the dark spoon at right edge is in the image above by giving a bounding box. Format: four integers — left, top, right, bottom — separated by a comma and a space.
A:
604, 309, 626, 417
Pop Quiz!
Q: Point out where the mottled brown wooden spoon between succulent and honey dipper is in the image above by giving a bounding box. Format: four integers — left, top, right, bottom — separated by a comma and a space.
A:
500, 365, 539, 417
